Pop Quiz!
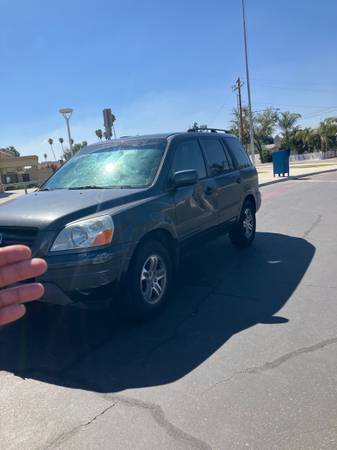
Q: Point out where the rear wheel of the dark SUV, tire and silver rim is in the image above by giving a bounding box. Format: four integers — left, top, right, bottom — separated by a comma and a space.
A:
229, 200, 256, 247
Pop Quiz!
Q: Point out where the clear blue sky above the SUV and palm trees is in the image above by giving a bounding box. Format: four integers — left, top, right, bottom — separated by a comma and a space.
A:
0, 0, 337, 158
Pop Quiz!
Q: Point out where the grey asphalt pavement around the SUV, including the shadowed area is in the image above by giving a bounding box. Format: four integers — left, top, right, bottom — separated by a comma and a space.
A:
0, 173, 337, 450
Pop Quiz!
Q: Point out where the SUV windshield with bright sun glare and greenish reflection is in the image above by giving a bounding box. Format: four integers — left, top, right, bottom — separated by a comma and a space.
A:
42, 140, 166, 190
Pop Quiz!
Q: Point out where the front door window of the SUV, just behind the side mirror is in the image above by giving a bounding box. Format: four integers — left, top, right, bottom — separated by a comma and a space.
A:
172, 140, 206, 179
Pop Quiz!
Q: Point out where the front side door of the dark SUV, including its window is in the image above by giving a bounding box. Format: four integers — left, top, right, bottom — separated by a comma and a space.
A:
170, 138, 218, 240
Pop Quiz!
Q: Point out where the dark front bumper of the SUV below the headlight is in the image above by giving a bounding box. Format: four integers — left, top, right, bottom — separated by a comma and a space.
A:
36, 244, 131, 308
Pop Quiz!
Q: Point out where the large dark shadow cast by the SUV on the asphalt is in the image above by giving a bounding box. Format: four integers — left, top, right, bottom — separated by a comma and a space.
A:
0, 232, 315, 392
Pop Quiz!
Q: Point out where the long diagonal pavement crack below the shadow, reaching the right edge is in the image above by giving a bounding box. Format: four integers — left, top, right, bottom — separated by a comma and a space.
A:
203, 338, 337, 394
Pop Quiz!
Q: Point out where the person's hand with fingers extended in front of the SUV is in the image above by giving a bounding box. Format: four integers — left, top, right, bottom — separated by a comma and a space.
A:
0, 245, 47, 325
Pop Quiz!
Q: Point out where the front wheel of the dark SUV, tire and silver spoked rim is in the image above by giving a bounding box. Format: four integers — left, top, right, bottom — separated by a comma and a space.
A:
121, 240, 173, 320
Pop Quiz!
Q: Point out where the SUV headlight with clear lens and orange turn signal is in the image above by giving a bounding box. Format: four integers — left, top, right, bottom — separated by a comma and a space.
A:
51, 216, 114, 252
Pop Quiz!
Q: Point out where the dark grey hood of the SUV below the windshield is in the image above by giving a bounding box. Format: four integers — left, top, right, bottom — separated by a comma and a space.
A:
0, 189, 144, 230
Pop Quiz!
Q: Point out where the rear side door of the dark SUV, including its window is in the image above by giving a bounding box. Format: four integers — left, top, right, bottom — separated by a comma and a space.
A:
200, 136, 242, 224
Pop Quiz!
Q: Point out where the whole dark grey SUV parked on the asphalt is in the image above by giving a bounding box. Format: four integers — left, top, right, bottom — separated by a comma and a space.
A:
0, 130, 261, 318
